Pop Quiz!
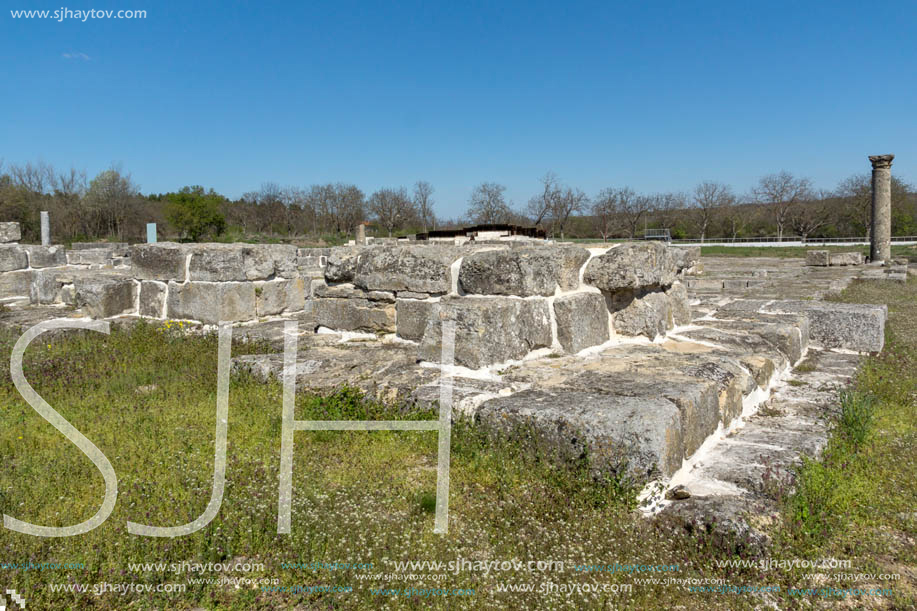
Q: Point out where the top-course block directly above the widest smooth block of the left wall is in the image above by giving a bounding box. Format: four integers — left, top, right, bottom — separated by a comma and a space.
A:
188, 244, 272, 282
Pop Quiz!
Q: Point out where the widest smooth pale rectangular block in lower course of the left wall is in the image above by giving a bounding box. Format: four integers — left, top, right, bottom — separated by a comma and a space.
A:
168, 282, 256, 324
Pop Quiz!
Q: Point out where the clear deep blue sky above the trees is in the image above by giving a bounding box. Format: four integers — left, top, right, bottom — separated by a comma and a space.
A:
0, 0, 917, 217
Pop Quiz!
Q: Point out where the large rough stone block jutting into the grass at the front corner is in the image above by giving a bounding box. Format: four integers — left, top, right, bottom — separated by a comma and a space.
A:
477, 389, 684, 483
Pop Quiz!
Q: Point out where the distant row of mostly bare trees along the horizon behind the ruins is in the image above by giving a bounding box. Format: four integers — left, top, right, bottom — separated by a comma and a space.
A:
0, 162, 917, 242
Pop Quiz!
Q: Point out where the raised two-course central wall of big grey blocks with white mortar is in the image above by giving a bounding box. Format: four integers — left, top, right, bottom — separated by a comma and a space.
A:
312, 242, 699, 369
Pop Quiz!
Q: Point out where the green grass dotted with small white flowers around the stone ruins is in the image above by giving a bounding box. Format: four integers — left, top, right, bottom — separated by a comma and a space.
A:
0, 280, 917, 609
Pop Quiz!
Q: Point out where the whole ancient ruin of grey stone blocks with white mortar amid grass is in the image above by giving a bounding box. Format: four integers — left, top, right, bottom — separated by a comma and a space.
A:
0, 223, 900, 539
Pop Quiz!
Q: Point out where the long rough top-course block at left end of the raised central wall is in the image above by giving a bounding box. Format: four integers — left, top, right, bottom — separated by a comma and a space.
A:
352, 245, 462, 295
